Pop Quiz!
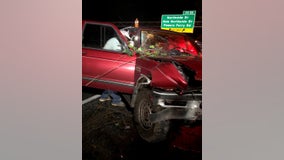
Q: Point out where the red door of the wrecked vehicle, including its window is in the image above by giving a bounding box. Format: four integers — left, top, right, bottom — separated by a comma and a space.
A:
82, 23, 136, 93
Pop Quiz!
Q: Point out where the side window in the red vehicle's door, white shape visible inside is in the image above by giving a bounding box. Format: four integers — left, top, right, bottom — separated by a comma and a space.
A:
82, 23, 121, 51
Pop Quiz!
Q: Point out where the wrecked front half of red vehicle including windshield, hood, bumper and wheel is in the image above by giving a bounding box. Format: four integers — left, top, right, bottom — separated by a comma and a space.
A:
125, 28, 202, 142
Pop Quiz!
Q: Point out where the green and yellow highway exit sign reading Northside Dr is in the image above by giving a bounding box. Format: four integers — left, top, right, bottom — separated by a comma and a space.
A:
161, 11, 196, 33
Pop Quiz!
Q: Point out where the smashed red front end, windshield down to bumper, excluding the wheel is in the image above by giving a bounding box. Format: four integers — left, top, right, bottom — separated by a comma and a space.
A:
132, 30, 202, 123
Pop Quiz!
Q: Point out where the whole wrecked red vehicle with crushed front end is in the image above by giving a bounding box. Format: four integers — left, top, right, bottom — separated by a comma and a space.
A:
82, 20, 202, 142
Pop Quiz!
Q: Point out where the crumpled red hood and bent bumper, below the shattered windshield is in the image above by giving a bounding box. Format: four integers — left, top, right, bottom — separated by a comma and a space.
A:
150, 57, 202, 122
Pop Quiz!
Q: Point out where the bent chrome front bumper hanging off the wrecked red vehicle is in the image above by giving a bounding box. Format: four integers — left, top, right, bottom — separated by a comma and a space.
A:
150, 90, 202, 123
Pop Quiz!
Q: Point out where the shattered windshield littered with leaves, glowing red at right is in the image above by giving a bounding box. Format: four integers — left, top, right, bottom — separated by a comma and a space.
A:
138, 30, 199, 56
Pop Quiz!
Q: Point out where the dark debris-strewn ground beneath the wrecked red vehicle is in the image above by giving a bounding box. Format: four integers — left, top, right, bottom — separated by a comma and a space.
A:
82, 88, 202, 160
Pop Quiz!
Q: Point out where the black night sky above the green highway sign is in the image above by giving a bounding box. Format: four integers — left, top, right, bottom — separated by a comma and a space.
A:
82, 0, 202, 21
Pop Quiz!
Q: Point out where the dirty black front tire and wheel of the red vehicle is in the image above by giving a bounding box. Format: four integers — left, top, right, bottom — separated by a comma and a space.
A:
134, 88, 170, 143
